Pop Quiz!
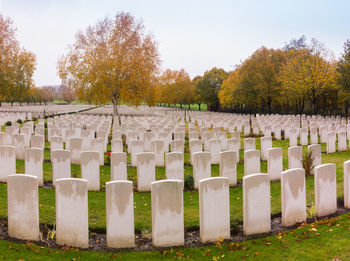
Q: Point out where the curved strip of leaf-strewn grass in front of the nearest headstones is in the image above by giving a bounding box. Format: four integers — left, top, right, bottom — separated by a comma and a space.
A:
0, 211, 350, 260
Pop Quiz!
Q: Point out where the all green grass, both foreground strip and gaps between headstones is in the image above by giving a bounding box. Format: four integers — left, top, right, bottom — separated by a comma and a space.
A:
0, 117, 350, 260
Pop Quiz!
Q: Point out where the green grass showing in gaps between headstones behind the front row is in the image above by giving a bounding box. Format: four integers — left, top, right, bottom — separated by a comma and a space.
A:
4, 134, 350, 232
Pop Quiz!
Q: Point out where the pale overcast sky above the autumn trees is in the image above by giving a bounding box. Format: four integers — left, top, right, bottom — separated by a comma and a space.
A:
0, 0, 350, 86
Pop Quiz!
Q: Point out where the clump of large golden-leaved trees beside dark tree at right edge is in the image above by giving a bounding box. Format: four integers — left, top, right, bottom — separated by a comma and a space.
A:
218, 36, 342, 114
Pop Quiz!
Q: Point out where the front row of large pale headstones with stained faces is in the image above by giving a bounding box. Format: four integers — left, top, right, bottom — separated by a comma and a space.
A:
7, 161, 344, 248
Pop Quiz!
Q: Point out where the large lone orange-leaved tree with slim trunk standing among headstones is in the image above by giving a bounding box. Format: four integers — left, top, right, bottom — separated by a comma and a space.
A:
58, 12, 160, 119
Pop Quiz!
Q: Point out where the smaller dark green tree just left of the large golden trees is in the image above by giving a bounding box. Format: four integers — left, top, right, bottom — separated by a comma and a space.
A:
195, 67, 229, 111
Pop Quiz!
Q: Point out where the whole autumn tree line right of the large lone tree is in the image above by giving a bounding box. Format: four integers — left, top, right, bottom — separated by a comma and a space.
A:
155, 36, 350, 115
